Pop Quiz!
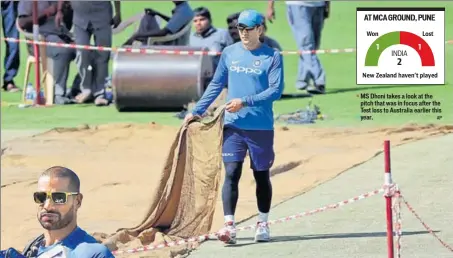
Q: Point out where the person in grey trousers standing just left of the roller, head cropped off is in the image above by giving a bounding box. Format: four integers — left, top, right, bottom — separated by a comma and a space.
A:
55, 0, 121, 106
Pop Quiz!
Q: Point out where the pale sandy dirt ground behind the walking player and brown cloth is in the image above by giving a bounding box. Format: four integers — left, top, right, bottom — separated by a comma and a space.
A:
1, 123, 453, 257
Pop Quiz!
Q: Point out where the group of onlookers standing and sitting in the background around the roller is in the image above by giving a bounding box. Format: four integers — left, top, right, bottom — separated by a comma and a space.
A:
1, 0, 330, 106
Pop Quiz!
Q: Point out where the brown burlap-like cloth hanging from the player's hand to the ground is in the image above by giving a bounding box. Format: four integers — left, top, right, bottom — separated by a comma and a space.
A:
98, 107, 224, 255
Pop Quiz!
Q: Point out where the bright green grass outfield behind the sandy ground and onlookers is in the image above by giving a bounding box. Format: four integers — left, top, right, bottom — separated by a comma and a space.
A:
1, 1, 453, 129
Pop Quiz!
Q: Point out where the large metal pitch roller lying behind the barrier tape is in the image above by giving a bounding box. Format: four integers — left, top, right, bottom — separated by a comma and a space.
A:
112, 46, 213, 111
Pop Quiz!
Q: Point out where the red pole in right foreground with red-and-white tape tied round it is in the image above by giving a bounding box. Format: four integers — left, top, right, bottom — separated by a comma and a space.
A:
384, 140, 394, 258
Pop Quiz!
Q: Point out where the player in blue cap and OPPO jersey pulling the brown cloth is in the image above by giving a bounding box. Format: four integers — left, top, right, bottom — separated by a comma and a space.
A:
185, 10, 284, 244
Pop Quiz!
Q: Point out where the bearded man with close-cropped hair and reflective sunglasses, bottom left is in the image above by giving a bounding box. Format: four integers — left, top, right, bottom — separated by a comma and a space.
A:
23, 166, 114, 258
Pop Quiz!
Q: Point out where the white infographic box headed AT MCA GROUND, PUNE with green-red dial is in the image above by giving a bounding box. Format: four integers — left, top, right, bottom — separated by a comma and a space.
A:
357, 8, 445, 85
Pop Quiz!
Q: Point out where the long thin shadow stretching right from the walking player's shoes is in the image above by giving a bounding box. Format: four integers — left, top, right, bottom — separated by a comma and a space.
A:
227, 231, 440, 247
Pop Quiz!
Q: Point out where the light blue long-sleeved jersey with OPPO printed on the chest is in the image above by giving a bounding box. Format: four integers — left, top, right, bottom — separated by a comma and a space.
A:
192, 42, 284, 130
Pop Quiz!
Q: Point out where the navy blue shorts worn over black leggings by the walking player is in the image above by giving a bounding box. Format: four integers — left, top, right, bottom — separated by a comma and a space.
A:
222, 126, 275, 171
